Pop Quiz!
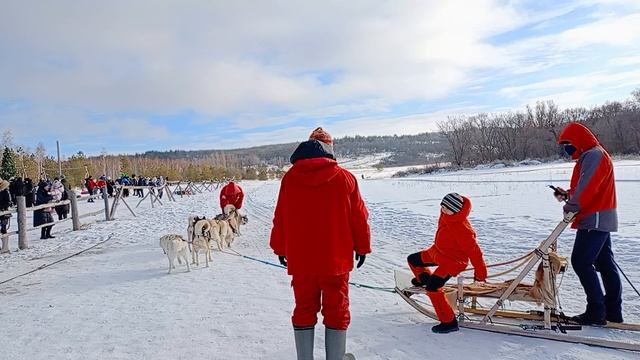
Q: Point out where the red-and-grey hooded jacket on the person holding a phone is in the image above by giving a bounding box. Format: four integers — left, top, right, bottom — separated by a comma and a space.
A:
558, 123, 618, 232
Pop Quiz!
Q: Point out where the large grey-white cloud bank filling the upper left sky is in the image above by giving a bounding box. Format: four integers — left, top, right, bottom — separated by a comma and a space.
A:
0, 0, 536, 115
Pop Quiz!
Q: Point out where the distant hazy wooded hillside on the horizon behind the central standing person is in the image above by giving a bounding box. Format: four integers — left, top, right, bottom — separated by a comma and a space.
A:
142, 133, 450, 167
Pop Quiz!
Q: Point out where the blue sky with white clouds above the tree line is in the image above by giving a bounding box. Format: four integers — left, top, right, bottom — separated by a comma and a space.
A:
0, 0, 640, 156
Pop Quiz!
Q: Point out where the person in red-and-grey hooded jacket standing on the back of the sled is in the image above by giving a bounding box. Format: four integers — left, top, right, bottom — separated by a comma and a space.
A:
555, 123, 623, 325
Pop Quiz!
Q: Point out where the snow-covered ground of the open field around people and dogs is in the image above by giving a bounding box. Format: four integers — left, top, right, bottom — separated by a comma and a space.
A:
0, 160, 640, 360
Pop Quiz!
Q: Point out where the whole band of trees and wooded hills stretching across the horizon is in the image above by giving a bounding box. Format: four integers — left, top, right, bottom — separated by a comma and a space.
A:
0, 89, 640, 186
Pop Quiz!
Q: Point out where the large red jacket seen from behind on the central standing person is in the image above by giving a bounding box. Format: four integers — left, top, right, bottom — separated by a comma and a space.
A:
270, 158, 371, 275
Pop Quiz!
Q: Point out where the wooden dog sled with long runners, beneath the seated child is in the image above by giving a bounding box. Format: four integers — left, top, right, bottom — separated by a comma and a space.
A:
394, 214, 640, 352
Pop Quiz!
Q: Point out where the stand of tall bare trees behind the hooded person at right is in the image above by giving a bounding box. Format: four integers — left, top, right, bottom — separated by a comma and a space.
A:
438, 89, 640, 166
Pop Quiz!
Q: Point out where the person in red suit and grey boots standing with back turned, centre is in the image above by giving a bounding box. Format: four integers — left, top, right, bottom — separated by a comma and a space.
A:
271, 128, 371, 359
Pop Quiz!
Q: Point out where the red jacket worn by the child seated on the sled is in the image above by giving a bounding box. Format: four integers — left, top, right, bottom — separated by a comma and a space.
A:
427, 196, 487, 281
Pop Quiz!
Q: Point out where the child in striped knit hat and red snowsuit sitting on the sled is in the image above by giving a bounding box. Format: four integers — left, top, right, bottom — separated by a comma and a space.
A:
407, 193, 487, 334
